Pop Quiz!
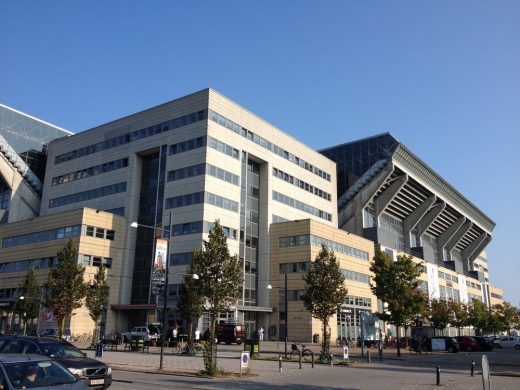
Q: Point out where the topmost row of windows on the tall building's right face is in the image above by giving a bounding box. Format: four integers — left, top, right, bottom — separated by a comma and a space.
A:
209, 110, 330, 181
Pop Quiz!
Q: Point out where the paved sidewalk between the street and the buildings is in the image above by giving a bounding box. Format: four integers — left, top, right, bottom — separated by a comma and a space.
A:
77, 341, 520, 376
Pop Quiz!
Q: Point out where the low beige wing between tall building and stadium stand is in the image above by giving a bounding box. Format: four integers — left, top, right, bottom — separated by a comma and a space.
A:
268, 219, 377, 342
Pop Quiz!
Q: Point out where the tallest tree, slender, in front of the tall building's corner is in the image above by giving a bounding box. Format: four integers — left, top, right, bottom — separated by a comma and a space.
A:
192, 220, 243, 375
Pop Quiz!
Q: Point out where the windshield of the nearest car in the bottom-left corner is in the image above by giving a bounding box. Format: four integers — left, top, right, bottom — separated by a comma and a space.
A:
4, 361, 77, 389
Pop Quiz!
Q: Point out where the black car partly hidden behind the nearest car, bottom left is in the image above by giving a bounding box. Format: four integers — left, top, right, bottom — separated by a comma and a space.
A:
0, 336, 112, 389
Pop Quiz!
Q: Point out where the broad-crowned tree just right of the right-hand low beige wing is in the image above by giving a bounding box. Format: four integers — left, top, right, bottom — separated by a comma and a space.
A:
370, 252, 427, 356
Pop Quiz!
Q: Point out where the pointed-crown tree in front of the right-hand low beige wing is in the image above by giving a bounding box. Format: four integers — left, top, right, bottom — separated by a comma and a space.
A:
303, 244, 348, 359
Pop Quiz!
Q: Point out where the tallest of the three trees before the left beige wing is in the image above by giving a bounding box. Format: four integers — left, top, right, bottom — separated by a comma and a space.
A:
47, 240, 86, 335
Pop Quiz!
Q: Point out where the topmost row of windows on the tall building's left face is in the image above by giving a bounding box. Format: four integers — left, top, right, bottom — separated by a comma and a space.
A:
54, 110, 207, 164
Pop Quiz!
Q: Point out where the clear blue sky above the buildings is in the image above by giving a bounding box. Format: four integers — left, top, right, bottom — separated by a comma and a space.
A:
0, 0, 520, 306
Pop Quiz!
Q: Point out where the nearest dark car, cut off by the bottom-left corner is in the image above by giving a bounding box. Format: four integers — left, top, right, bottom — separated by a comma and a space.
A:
0, 355, 88, 390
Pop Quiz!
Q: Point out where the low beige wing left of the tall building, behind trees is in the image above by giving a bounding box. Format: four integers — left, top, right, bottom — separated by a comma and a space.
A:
0, 208, 127, 335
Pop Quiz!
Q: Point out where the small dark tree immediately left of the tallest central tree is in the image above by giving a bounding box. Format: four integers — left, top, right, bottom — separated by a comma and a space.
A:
177, 265, 205, 349
